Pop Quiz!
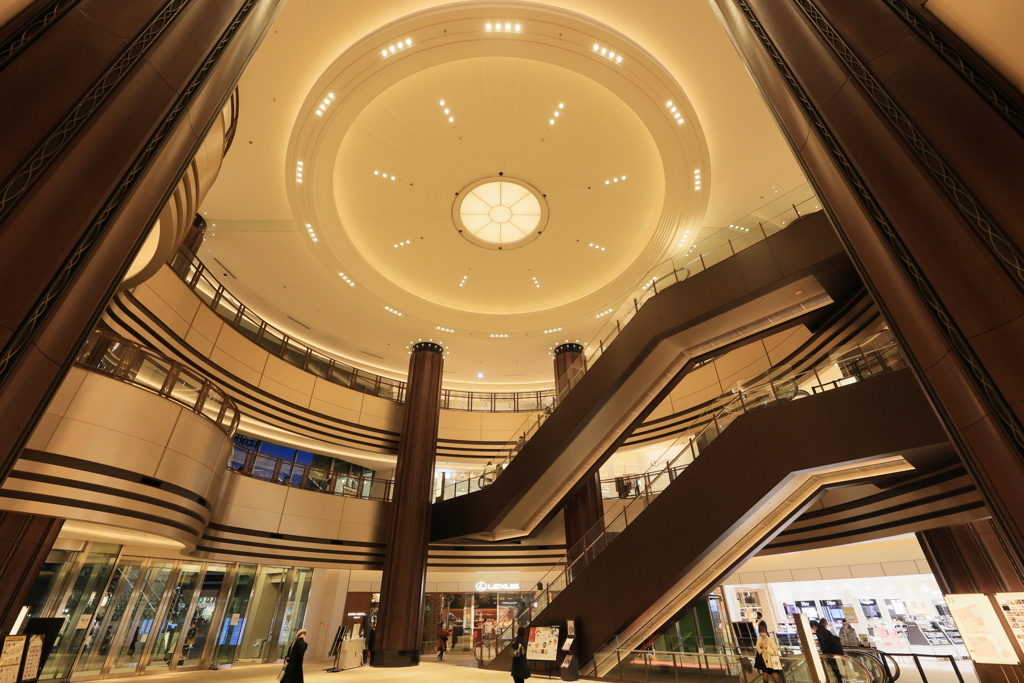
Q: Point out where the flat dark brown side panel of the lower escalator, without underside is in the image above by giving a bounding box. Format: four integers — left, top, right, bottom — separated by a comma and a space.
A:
520, 371, 946, 661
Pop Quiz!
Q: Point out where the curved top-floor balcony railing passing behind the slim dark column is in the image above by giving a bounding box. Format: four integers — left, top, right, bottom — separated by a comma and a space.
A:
167, 245, 555, 413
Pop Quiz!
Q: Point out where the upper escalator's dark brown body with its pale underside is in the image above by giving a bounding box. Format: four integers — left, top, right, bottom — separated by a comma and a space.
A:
430, 212, 860, 543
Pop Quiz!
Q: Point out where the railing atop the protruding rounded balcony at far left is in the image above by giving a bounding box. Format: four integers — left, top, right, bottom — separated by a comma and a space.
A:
75, 330, 241, 436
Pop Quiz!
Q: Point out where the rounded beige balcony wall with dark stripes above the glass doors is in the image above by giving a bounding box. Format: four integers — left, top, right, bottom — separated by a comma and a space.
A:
0, 368, 231, 548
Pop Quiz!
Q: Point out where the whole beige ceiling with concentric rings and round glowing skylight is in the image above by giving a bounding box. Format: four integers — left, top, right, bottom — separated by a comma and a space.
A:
195, 2, 800, 390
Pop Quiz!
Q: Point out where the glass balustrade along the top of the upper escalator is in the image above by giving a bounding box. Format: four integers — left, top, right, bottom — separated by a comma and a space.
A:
436, 184, 820, 501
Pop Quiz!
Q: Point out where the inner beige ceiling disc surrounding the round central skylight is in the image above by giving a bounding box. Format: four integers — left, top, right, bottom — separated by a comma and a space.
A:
327, 57, 664, 313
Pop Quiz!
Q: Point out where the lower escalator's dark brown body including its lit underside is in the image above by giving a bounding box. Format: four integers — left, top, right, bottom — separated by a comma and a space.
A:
488, 366, 947, 677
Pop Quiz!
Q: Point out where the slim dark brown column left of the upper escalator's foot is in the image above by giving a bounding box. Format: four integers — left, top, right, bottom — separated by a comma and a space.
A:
370, 342, 444, 667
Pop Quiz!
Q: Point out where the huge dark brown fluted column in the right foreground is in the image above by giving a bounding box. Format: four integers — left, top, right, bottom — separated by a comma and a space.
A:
713, 0, 1024, 567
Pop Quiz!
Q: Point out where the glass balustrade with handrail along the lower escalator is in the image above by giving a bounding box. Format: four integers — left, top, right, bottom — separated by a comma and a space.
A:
481, 342, 907, 659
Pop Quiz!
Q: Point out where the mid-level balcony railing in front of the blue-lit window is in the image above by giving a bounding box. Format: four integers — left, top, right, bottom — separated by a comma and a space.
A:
227, 445, 394, 501
